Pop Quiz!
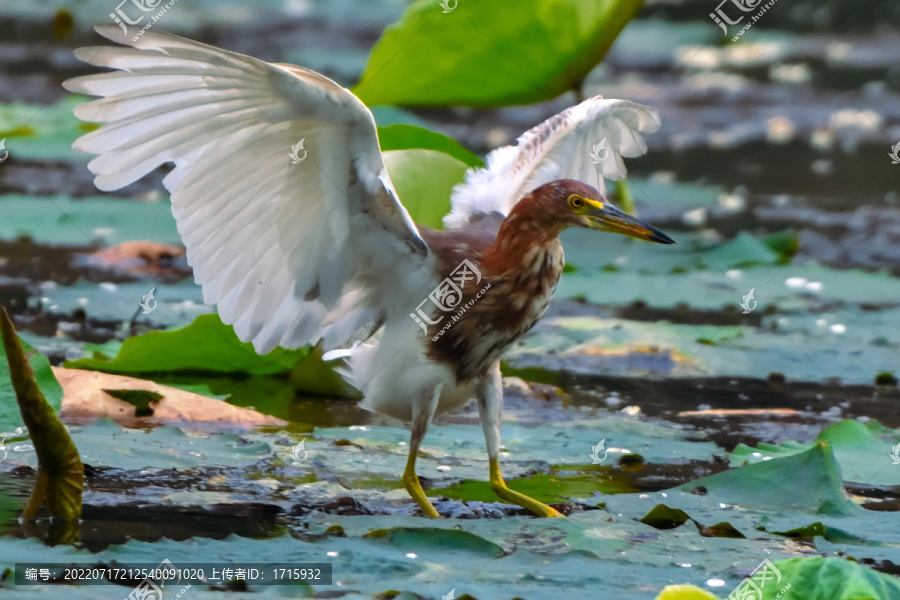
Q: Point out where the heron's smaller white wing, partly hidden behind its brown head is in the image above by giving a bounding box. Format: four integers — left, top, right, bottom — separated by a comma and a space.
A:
444, 96, 660, 228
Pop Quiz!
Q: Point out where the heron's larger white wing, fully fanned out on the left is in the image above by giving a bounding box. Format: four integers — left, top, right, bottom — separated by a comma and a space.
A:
64, 24, 436, 353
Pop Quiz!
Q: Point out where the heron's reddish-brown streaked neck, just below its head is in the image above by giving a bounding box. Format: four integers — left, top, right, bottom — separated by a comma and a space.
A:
482, 194, 566, 273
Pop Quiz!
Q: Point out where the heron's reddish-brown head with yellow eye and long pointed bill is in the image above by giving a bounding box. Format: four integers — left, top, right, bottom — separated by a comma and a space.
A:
532, 179, 675, 244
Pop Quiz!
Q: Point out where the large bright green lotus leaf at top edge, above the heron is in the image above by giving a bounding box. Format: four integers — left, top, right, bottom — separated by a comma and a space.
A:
353, 0, 642, 106
